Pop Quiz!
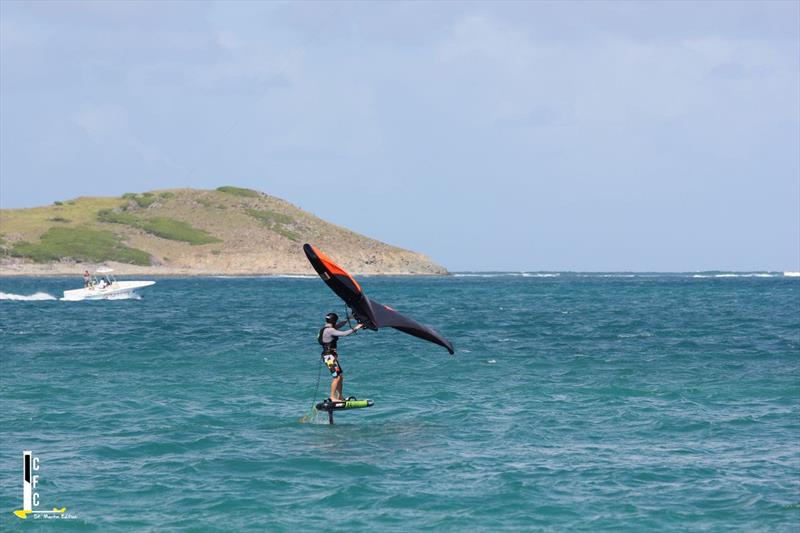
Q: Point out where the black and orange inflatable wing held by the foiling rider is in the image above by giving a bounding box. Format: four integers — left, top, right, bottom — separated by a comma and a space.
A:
303, 244, 454, 354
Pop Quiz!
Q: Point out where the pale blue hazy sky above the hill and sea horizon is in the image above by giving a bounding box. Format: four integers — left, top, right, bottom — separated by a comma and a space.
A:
0, 0, 800, 271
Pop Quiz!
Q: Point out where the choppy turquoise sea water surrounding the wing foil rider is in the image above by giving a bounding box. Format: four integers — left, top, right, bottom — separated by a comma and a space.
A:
0, 273, 800, 532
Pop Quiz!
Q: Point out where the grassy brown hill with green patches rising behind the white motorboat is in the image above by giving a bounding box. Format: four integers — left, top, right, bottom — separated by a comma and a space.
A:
0, 187, 447, 275
